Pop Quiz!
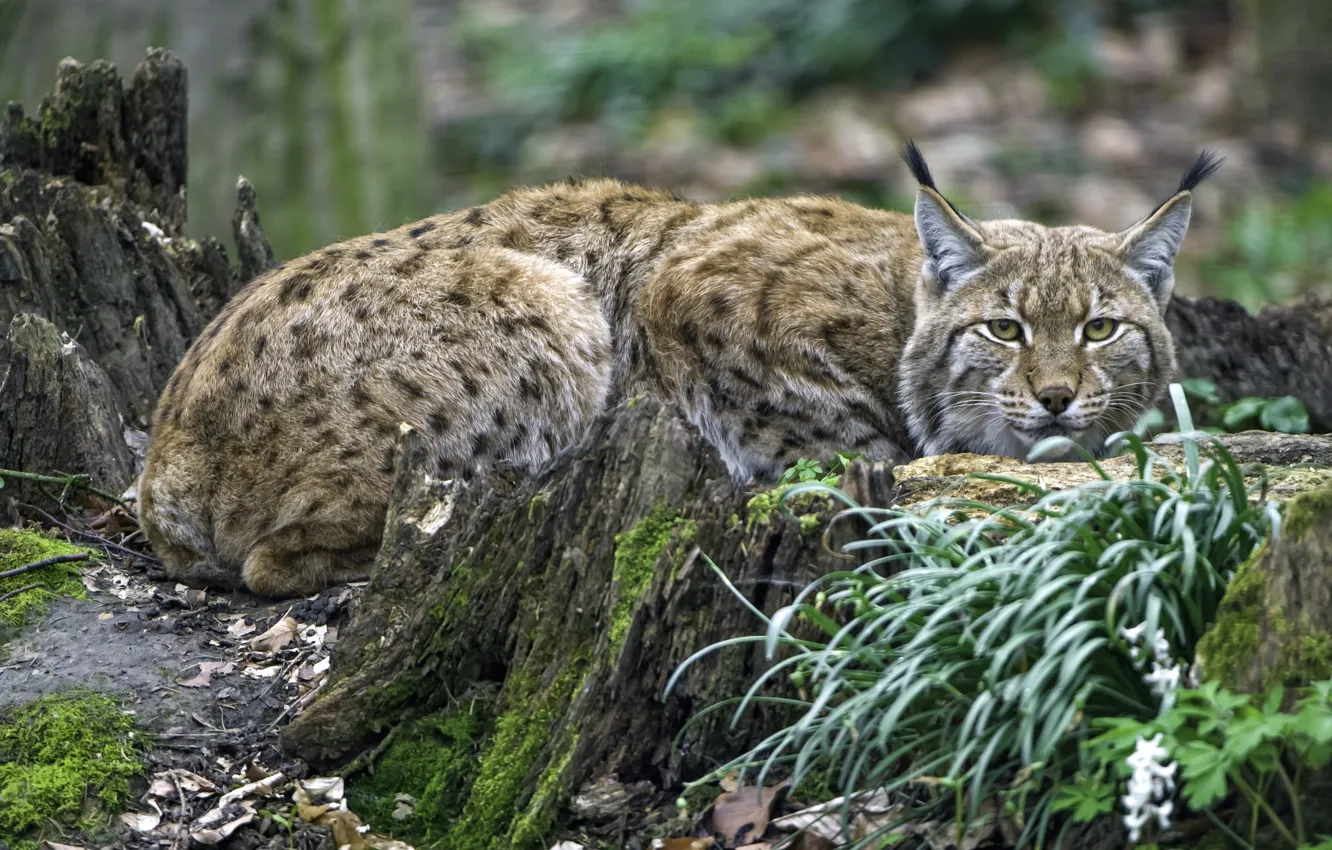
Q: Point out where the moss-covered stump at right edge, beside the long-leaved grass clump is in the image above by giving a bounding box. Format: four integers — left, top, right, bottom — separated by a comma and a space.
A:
1197, 486, 1332, 693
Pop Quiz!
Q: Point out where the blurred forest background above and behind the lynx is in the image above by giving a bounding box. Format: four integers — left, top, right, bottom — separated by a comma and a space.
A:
0, 0, 1332, 306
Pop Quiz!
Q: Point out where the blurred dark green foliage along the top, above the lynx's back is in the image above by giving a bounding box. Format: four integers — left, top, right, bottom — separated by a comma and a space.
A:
447, 0, 1081, 159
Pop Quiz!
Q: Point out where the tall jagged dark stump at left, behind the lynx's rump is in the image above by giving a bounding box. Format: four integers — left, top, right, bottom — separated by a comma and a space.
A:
0, 49, 272, 428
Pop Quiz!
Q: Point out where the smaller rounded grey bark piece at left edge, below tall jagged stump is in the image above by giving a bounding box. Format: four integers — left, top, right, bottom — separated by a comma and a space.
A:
0, 314, 133, 504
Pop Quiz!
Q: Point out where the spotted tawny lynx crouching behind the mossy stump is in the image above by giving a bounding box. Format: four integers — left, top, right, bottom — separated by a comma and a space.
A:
139, 144, 1220, 596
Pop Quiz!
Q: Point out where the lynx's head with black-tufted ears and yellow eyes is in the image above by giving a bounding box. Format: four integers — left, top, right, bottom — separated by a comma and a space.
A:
900, 144, 1221, 457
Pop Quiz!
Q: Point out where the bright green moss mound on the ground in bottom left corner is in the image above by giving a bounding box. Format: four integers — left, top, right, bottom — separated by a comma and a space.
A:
0, 691, 147, 843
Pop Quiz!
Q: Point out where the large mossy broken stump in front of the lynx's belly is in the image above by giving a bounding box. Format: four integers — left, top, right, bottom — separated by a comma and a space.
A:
282, 401, 863, 850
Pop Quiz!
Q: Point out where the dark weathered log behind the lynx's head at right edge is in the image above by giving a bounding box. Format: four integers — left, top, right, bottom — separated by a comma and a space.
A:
1166, 296, 1332, 433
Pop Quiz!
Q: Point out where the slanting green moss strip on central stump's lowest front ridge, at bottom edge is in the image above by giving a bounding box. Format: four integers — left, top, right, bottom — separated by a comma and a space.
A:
442, 659, 587, 850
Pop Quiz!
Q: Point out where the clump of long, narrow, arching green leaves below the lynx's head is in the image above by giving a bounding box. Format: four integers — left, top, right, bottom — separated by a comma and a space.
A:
667, 385, 1280, 846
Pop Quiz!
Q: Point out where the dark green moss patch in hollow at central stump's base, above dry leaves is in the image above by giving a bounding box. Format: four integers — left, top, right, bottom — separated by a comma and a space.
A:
348, 710, 489, 843
